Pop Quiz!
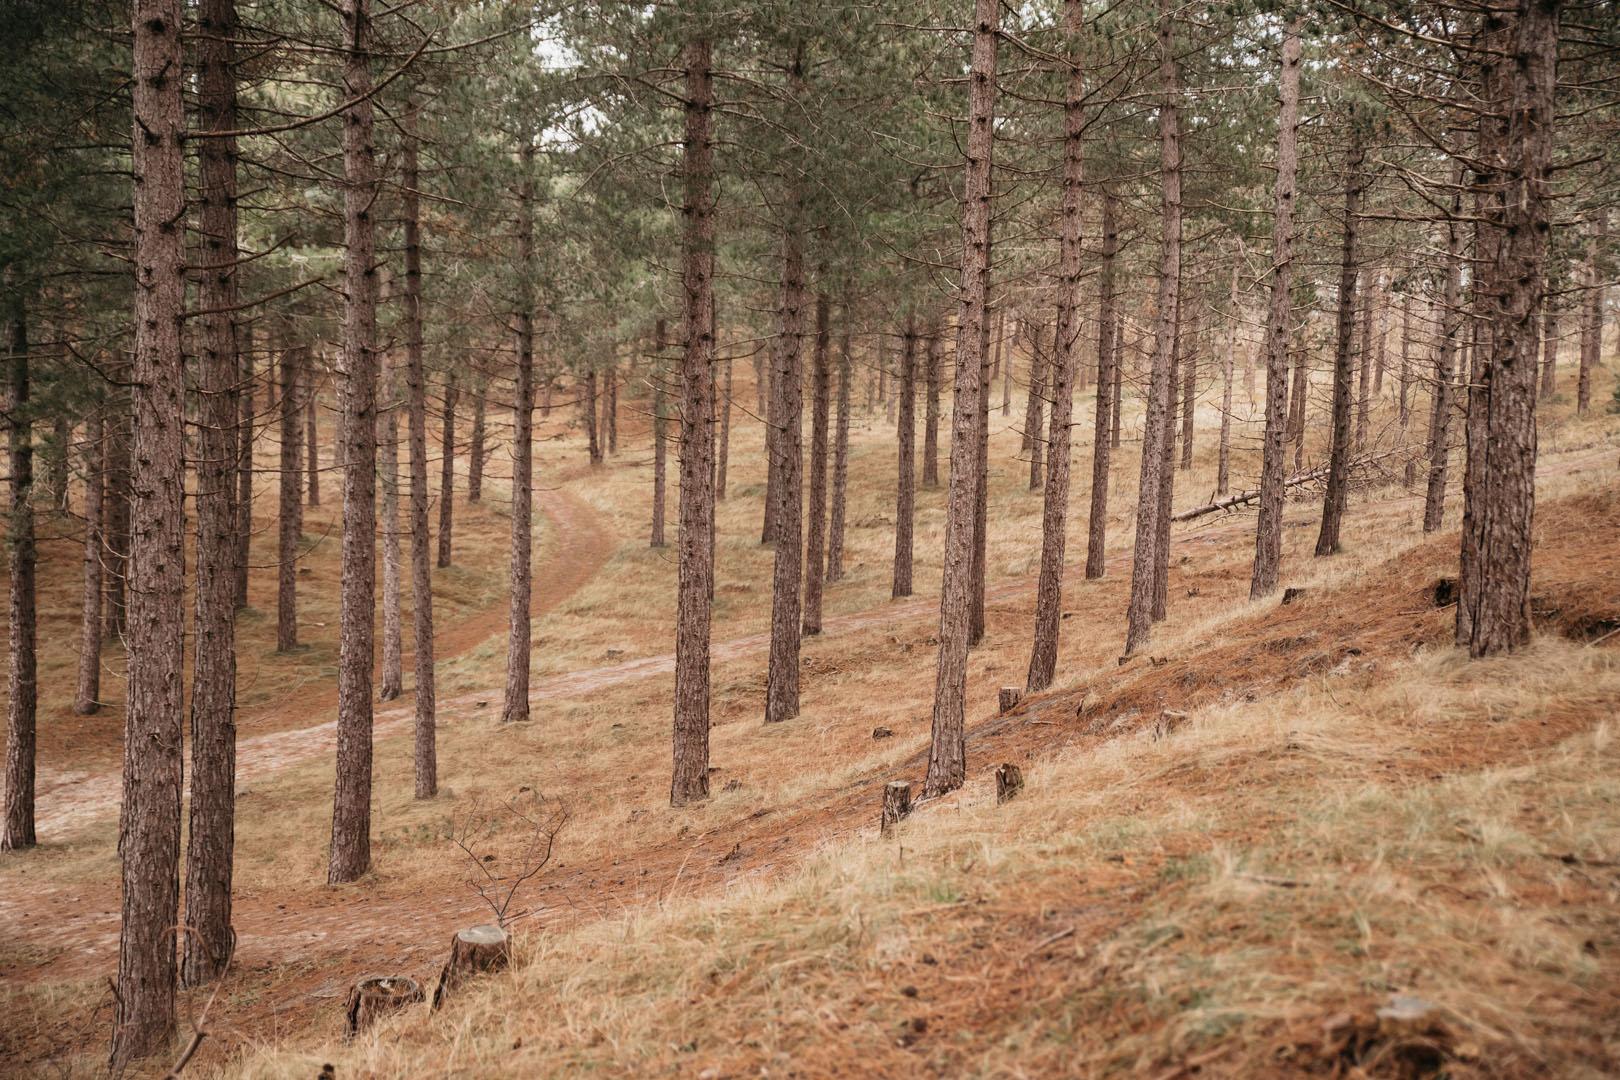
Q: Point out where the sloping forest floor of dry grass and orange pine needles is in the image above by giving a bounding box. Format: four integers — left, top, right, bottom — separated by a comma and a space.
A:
0, 359, 1620, 1077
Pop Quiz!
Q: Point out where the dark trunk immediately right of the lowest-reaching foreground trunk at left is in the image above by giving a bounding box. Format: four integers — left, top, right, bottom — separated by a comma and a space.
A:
180, 0, 240, 986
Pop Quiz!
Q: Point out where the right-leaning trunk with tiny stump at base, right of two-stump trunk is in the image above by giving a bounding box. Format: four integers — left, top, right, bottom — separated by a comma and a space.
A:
1024, 0, 1085, 691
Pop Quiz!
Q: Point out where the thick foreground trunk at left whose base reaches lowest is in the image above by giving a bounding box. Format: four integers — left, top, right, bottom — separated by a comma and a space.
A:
113, 0, 186, 1072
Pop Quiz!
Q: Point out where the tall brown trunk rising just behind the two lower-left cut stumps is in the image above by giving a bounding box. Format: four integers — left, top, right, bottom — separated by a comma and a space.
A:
326, 0, 377, 886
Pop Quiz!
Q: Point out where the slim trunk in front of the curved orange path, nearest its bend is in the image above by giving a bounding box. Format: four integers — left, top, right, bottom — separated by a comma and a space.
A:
498, 136, 535, 724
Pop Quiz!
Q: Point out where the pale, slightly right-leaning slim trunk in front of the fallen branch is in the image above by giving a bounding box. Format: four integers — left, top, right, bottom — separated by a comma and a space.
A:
1249, 18, 1301, 601
